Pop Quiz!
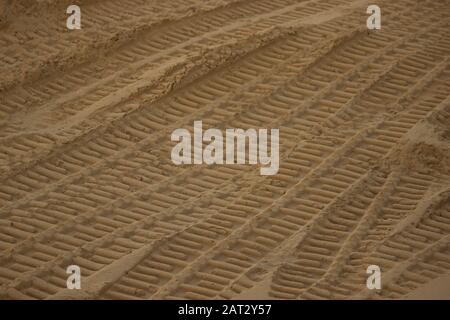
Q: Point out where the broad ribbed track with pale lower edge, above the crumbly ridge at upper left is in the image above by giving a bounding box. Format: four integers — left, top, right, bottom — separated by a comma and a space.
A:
0, 1, 342, 122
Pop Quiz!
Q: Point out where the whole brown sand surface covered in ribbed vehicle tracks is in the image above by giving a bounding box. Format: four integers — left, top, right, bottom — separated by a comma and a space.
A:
0, 0, 450, 299
